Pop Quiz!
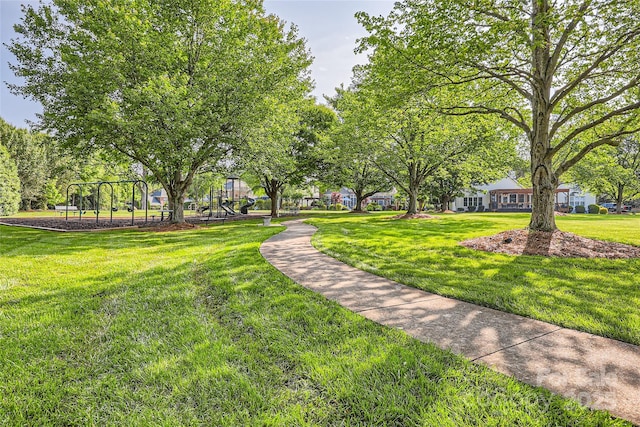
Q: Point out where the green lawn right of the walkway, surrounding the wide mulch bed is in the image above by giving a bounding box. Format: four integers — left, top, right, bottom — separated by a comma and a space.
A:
311, 213, 640, 344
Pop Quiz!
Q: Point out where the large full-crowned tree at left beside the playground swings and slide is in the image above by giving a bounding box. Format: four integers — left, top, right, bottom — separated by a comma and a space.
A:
10, 0, 310, 222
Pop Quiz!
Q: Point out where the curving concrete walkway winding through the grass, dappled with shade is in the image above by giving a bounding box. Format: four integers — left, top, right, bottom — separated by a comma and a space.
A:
260, 220, 640, 425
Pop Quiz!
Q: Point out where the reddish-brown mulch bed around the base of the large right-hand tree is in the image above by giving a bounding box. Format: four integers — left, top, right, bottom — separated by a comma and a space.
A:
460, 229, 640, 259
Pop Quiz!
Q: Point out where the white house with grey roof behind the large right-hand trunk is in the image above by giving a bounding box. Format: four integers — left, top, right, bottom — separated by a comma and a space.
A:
454, 177, 596, 212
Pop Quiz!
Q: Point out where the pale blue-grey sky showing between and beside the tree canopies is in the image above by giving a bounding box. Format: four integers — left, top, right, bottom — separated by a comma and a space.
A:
0, 0, 394, 127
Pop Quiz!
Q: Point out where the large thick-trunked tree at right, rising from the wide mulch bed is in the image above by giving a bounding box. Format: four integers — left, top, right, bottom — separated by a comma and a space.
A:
360, 0, 640, 230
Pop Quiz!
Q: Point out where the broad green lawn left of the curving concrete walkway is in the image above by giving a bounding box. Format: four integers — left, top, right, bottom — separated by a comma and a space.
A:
0, 221, 624, 426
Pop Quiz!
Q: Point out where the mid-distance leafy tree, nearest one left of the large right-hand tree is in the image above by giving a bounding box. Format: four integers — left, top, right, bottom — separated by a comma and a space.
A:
342, 81, 505, 214
